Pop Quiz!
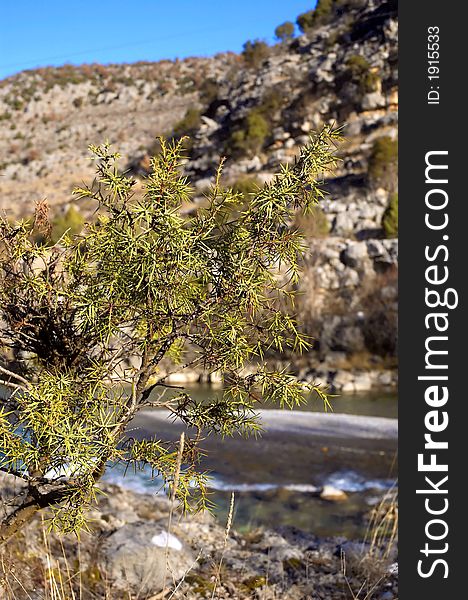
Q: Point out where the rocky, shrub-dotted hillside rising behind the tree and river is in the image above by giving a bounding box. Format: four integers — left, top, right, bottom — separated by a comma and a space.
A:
0, 0, 398, 378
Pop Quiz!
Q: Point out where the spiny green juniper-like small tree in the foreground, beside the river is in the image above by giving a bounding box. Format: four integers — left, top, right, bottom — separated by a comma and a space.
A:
0, 127, 339, 541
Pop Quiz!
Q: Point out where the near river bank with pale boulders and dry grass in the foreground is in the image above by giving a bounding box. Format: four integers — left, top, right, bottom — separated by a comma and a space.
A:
1, 478, 398, 600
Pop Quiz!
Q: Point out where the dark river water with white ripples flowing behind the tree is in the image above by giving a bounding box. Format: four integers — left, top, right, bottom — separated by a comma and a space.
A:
107, 386, 397, 538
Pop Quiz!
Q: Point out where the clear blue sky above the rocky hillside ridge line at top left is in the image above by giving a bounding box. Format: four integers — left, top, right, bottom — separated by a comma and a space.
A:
0, 0, 315, 79
